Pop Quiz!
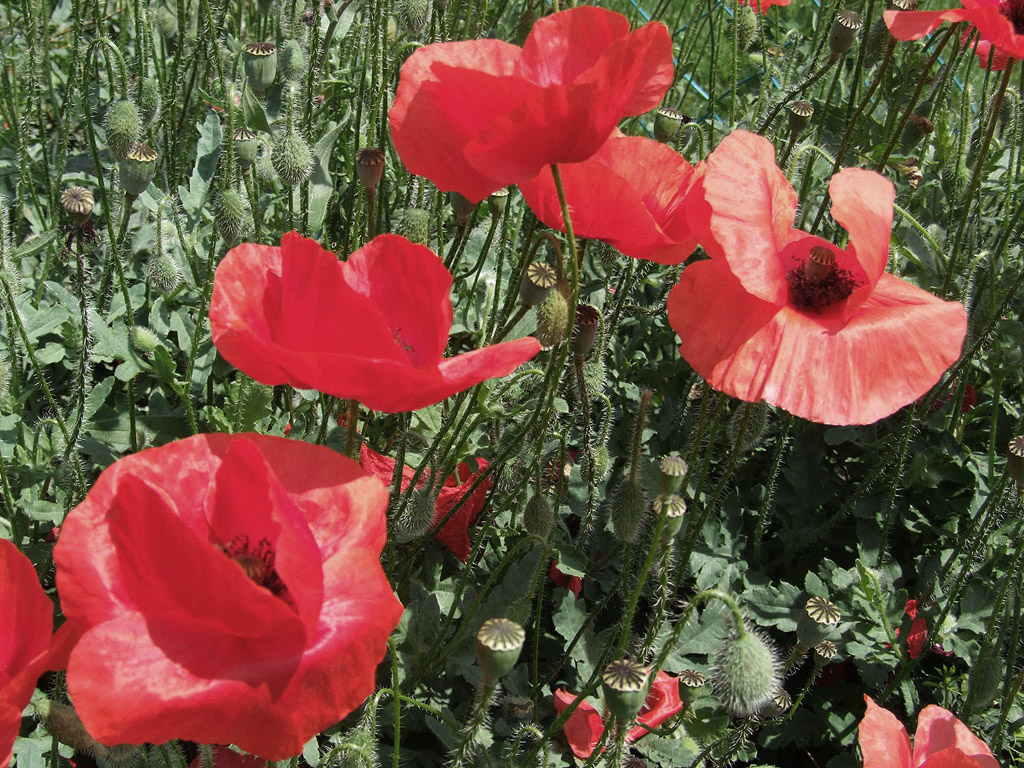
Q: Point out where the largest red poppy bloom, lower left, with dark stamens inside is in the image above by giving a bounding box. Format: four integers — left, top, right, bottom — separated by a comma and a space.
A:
54, 434, 402, 760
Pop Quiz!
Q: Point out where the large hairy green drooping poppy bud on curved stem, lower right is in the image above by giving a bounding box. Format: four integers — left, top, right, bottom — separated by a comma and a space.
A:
714, 629, 779, 717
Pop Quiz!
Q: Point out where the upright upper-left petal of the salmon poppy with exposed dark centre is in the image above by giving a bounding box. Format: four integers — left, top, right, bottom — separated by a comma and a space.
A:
703, 131, 797, 304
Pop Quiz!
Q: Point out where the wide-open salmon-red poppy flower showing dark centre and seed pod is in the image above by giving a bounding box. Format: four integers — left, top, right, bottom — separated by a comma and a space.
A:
669, 131, 967, 424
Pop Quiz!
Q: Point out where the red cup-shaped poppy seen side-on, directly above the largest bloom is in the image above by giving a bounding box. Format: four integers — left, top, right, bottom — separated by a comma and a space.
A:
210, 232, 541, 413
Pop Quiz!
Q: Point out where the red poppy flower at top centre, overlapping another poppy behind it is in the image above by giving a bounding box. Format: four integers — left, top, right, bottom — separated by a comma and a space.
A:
388, 7, 673, 203
